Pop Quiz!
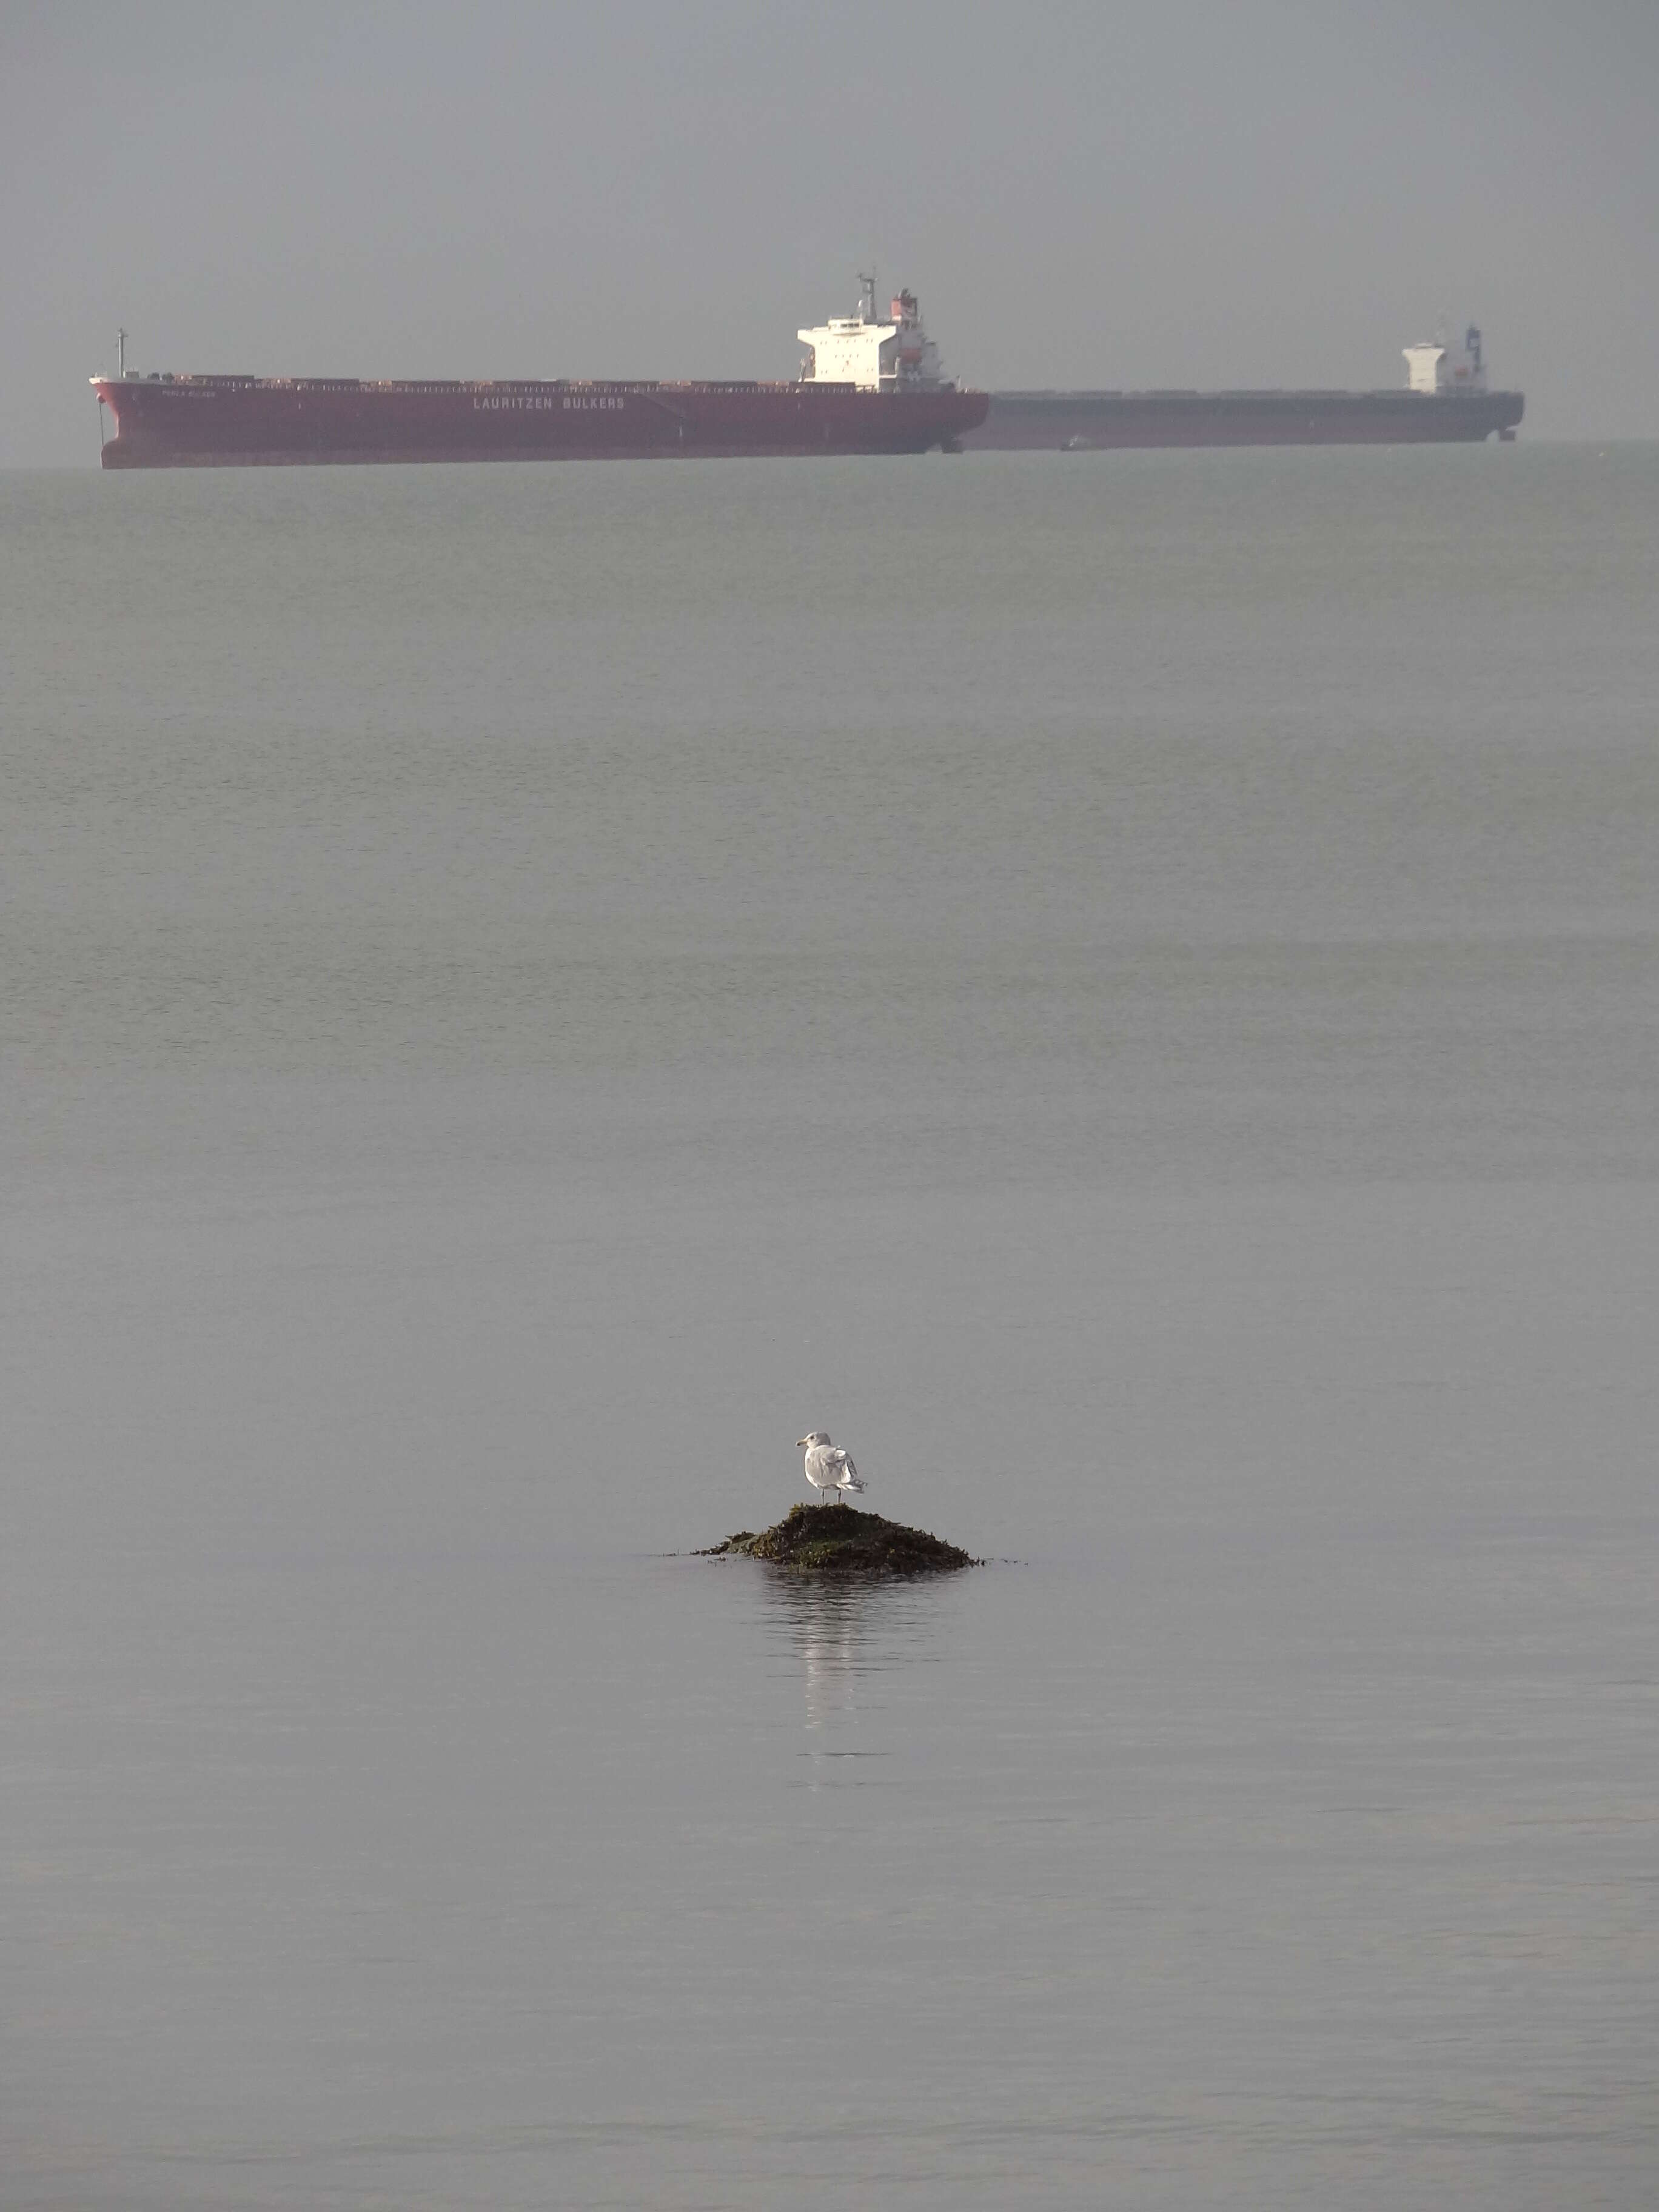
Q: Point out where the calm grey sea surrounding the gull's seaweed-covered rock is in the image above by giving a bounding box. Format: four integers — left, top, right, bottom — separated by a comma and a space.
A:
0, 444, 1659, 2212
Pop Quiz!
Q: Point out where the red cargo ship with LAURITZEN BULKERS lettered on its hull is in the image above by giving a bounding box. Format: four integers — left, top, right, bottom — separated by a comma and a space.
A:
91, 279, 989, 469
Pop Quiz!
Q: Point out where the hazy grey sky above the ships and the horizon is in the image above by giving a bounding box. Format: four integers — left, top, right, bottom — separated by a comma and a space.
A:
0, 0, 1659, 464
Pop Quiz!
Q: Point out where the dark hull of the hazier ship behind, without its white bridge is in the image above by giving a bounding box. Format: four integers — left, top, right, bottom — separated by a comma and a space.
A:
962, 392, 1526, 451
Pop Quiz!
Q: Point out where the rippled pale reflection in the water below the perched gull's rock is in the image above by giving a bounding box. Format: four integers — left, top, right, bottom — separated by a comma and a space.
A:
763, 1575, 951, 1789
